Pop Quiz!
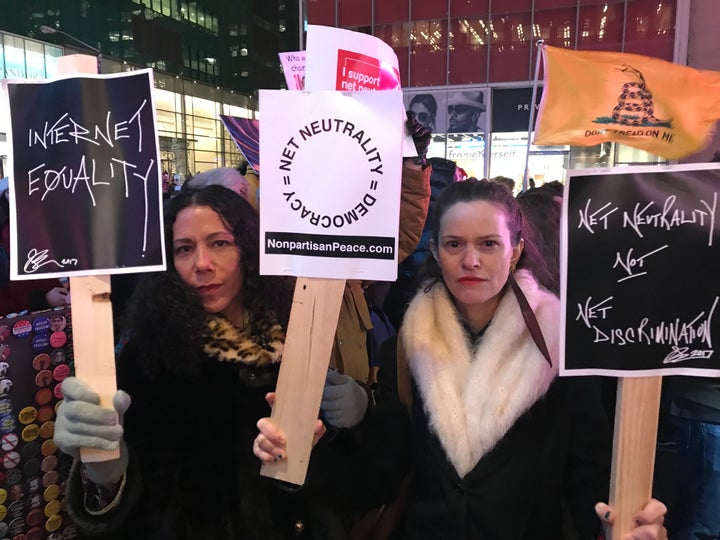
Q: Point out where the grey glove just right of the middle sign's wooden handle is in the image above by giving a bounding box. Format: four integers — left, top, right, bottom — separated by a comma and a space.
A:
320, 370, 368, 428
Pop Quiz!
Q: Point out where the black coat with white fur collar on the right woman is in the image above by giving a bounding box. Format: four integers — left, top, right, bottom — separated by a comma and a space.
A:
379, 272, 612, 540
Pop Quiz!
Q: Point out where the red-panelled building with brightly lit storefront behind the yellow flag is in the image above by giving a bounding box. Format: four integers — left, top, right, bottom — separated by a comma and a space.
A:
305, 0, 684, 184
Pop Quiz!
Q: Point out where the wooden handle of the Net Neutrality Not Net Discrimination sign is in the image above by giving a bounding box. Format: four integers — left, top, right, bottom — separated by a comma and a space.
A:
608, 377, 662, 540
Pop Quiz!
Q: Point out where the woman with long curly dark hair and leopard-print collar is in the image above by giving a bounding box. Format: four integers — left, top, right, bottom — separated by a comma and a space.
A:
55, 186, 339, 540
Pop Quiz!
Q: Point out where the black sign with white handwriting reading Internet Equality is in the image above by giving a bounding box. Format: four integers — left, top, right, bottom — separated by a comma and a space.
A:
6, 70, 165, 279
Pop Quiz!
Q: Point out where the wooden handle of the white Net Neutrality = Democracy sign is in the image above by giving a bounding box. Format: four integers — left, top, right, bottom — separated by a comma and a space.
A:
260, 278, 345, 485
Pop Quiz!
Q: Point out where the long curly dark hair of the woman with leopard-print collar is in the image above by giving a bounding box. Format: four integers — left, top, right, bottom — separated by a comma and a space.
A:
123, 185, 293, 373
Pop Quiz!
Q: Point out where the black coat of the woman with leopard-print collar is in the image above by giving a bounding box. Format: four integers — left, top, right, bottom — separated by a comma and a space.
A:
67, 314, 386, 540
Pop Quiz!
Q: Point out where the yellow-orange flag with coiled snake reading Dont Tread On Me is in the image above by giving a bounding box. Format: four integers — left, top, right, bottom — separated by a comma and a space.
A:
534, 46, 720, 159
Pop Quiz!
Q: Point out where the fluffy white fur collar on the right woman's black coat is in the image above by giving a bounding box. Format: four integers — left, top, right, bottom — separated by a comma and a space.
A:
402, 270, 560, 477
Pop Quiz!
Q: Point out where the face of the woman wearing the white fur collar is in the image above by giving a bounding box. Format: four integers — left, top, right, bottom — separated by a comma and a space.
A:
431, 201, 522, 330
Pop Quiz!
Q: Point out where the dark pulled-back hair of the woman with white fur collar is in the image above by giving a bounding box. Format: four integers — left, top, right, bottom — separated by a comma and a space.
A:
423, 178, 547, 291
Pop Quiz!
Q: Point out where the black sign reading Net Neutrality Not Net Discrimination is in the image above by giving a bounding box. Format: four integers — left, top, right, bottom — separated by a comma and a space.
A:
561, 165, 720, 376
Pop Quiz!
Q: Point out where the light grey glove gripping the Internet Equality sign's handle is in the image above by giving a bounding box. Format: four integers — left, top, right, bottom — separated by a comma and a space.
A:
54, 377, 130, 485
